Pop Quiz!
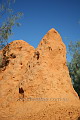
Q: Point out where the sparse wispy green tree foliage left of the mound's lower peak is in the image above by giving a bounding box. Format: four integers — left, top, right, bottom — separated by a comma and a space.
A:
0, 0, 23, 49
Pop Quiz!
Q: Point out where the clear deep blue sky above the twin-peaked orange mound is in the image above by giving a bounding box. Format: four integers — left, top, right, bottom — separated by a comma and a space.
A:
0, 0, 80, 61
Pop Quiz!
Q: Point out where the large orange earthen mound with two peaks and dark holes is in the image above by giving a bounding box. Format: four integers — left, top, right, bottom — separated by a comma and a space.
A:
0, 29, 80, 120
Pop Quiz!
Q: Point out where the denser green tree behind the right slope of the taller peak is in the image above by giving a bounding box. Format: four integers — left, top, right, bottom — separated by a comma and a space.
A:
68, 41, 80, 96
